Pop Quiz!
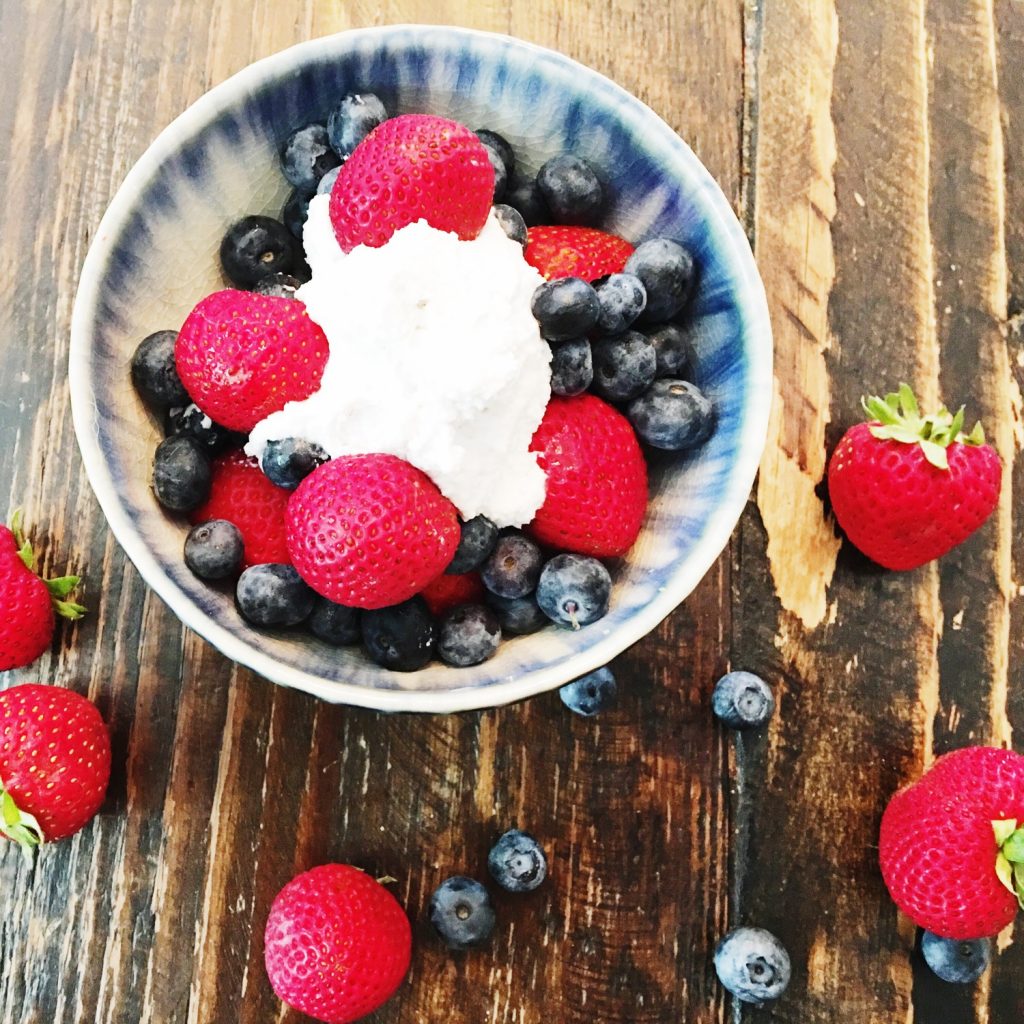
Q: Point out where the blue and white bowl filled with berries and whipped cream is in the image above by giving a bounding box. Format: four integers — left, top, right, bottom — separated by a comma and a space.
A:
70, 26, 772, 712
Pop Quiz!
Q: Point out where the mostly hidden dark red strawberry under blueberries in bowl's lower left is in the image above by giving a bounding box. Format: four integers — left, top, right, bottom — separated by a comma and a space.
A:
189, 452, 292, 568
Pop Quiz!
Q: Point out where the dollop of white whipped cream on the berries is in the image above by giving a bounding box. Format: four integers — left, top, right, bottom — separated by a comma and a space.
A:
246, 196, 551, 526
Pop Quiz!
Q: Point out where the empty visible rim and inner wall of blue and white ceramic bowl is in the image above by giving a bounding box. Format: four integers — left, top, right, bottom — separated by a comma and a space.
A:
71, 26, 772, 712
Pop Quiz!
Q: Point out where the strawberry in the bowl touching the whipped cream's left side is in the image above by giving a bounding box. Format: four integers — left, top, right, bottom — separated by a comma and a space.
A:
174, 288, 328, 431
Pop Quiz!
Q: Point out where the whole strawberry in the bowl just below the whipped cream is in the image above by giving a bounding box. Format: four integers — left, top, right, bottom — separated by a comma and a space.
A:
285, 455, 459, 608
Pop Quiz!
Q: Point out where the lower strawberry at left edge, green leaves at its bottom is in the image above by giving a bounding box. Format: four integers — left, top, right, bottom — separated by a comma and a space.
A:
0, 683, 111, 854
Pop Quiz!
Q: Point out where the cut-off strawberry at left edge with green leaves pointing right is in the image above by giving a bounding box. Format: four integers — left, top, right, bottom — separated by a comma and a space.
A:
0, 512, 85, 672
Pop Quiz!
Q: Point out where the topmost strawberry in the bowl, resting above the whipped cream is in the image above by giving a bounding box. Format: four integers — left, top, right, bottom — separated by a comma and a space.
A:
331, 114, 495, 252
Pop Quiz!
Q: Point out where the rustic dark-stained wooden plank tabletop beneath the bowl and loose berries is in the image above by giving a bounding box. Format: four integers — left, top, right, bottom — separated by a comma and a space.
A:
0, 0, 1024, 1024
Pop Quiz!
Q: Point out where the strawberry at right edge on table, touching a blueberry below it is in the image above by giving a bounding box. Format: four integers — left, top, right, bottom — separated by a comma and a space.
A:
879, 746, 1024, 940
